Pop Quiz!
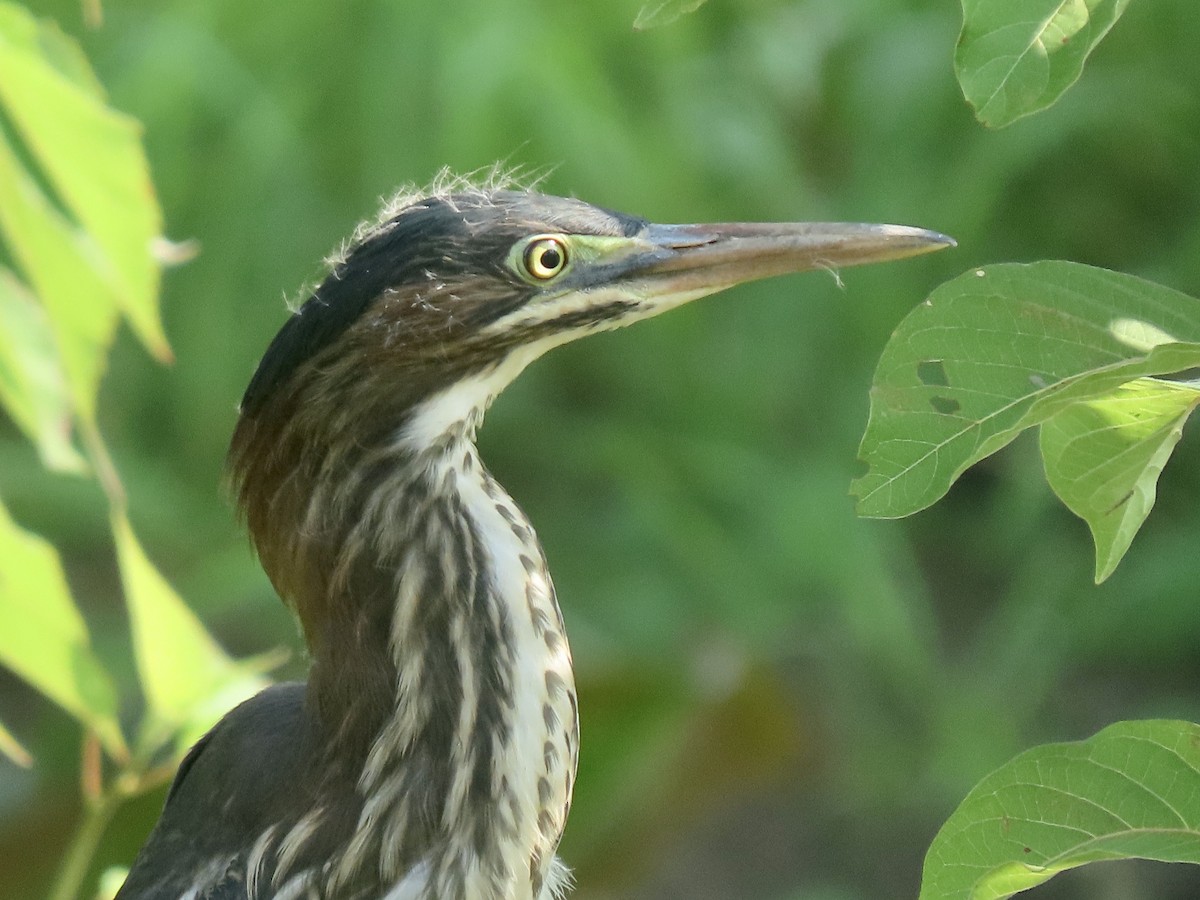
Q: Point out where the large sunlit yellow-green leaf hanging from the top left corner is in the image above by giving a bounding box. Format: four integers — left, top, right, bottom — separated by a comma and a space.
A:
0, 4, 170, 360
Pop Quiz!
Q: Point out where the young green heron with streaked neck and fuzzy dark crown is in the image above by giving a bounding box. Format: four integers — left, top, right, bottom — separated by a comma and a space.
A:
118, 180, 953, 900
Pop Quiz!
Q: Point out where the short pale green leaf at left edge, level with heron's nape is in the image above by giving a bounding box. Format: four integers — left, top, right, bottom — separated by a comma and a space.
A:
0, 265, 85, 472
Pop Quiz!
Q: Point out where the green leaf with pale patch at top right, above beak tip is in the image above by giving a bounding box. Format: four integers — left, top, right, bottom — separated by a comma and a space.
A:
954, 0, 1129, 128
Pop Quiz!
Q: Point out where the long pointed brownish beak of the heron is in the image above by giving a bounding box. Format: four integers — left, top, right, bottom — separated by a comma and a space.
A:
626, 222, 954, 295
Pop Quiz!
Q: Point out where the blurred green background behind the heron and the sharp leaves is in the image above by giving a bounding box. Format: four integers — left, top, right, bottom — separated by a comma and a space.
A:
0, 0, 1200, 900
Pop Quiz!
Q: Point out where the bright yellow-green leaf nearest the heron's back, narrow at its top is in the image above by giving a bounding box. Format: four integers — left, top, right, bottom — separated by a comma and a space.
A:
113, 514, 269, 750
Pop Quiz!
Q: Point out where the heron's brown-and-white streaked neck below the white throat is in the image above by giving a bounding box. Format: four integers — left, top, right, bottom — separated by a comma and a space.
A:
306, 419, 577, 898
